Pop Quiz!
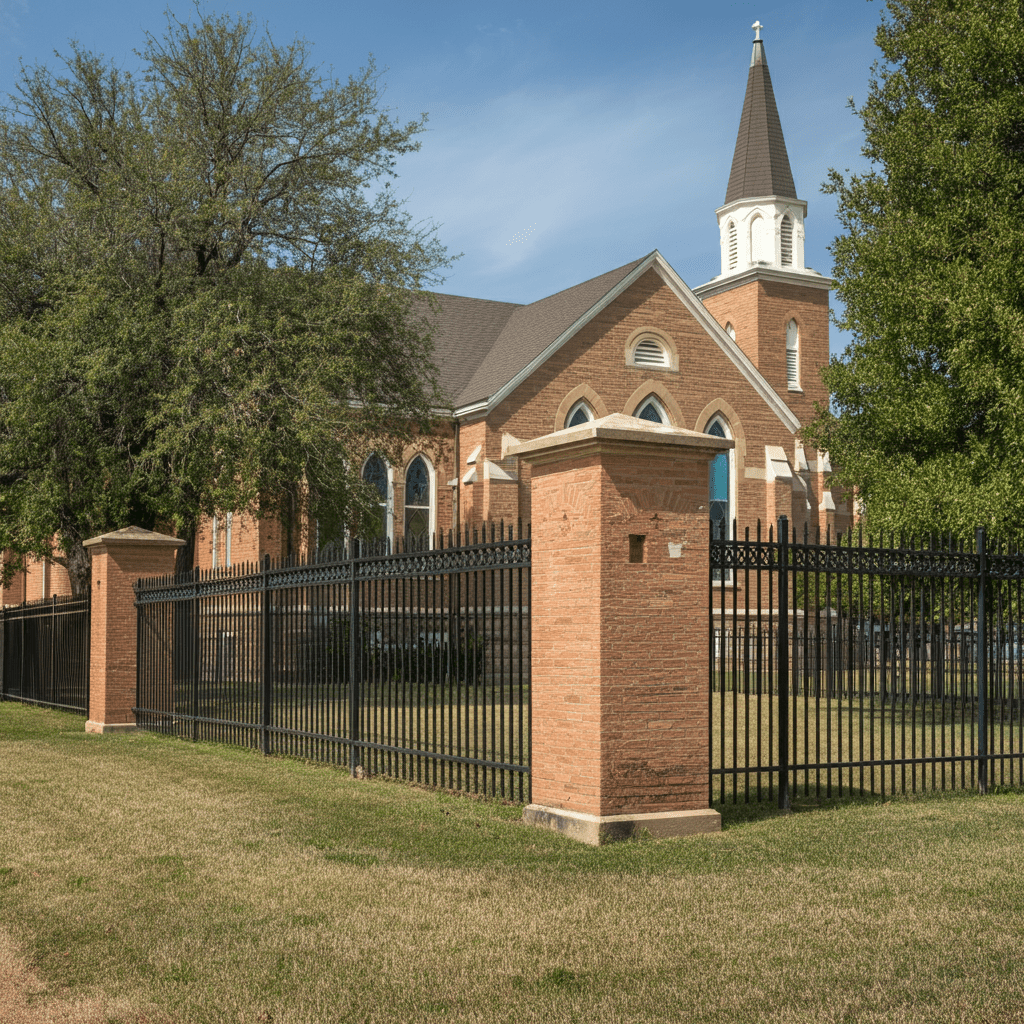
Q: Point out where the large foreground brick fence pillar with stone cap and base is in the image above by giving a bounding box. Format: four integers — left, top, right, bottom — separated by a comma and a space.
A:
509, 414, 733, 844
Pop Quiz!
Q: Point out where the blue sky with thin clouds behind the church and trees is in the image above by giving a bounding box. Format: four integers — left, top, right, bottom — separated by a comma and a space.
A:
0, 0, 883, 352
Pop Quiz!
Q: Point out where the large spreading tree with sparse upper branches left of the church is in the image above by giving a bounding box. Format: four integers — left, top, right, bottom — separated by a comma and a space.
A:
0, 15, 449, 593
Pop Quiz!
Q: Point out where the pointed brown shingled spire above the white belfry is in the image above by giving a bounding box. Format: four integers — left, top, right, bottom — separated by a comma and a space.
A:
725, 39, 797, 204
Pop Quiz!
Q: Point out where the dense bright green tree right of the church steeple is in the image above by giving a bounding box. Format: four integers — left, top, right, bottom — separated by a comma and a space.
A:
807, 0, 1024, 538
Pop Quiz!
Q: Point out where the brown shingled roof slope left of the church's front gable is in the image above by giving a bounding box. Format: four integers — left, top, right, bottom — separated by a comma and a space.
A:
419, 257, 646, 409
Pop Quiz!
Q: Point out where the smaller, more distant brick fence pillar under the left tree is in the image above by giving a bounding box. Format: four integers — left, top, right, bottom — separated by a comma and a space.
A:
85, 526, 185, 732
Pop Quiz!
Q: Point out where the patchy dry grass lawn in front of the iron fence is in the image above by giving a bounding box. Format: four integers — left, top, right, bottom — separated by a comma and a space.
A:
0, 702, 1024, 1024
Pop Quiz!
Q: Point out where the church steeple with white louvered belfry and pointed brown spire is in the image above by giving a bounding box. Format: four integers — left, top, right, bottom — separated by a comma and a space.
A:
715, 22, 813, 280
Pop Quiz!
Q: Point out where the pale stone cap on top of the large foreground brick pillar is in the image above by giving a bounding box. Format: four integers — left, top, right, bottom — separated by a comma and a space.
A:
505, 413, 735, 462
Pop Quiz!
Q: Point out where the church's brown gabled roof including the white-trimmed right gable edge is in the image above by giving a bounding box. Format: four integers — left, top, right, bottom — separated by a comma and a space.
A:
421, 249, 800, 432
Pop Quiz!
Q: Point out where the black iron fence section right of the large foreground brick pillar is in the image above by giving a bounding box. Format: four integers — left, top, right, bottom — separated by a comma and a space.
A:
709, 518, 1024, 805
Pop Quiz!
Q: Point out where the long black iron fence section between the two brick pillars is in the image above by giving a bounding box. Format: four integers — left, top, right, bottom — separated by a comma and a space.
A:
135, 524, 530, 800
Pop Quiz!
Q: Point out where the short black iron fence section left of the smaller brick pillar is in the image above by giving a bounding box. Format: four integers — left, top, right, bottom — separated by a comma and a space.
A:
0, 596, 89, 714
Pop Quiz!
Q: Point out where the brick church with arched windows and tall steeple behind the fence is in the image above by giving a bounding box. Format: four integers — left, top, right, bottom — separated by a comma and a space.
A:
0, 26, 850, 603
